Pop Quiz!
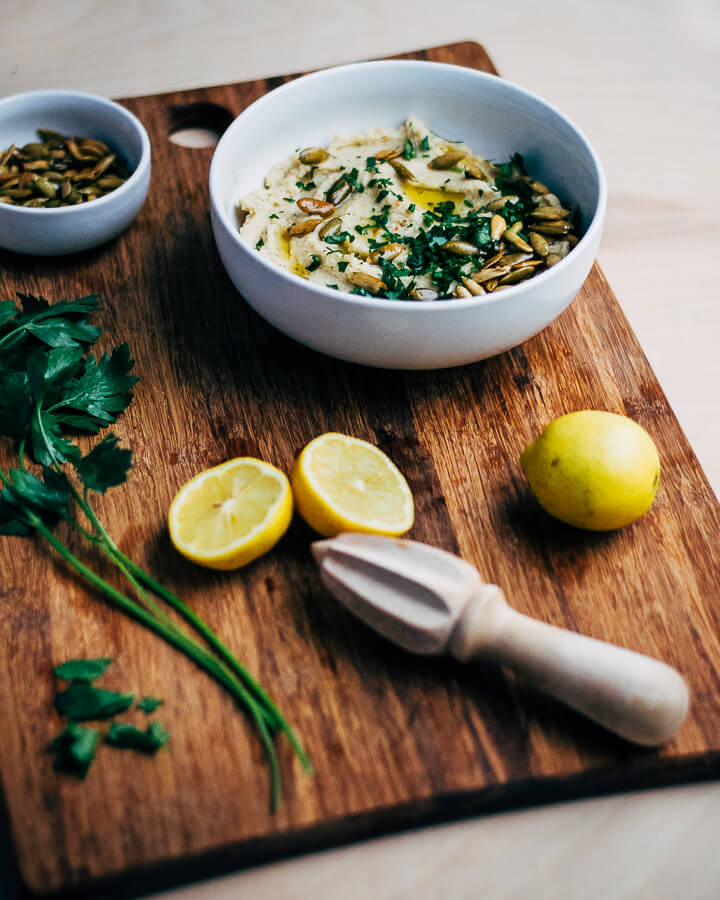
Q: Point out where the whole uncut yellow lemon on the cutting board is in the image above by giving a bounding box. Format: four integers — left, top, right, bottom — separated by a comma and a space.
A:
520, 410, 660, 531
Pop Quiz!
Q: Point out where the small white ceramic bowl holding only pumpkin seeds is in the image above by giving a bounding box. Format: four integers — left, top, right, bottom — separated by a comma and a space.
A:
0, 90, 150, 256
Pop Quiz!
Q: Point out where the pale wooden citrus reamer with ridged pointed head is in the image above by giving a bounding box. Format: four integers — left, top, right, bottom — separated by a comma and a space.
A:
312, 534, 689, 746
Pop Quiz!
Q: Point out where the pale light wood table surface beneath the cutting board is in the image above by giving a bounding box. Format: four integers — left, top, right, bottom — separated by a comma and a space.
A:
0, 0, 720, 900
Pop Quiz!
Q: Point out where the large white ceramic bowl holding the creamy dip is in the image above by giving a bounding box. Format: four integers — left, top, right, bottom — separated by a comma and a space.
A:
210, 61, 606, 369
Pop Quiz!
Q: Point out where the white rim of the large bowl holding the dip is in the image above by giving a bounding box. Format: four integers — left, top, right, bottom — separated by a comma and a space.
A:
208, 59, 607, 315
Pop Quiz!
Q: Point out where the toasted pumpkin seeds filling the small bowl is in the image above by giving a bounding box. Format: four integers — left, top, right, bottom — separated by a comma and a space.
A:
0, 128, 131, 209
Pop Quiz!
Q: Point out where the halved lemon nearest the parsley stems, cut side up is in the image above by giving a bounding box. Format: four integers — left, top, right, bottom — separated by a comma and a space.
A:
168, 456, 293, 569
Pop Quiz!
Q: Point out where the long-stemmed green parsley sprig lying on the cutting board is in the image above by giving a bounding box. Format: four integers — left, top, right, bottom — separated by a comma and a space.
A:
0, 294, 312, 809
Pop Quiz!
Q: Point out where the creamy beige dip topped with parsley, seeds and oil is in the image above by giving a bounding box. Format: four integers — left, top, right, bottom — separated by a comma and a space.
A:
237, 118, 578, 301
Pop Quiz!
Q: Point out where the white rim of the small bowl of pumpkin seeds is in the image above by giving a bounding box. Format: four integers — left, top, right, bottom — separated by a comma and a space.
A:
0, 88, 152, 218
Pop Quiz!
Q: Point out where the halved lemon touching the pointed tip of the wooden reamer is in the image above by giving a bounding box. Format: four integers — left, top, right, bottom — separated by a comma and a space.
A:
290, 432, 414, 537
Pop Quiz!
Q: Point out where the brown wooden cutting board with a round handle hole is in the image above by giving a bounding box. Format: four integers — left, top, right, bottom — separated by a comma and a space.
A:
0, 43, 720, 896
